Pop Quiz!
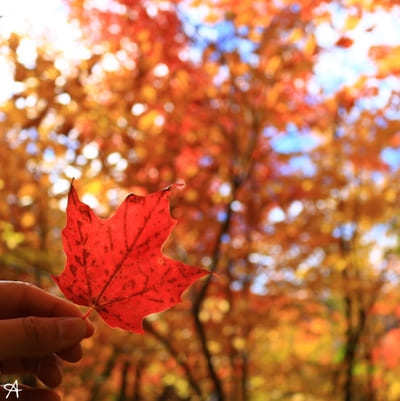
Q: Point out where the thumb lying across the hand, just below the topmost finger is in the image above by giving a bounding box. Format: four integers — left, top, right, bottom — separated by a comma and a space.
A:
0, 316, 87, 359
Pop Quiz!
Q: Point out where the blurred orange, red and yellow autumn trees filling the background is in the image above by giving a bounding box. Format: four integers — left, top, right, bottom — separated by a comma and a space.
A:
0, 0, 400, 401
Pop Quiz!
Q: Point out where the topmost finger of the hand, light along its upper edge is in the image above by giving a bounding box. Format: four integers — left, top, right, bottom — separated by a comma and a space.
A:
0, 281, 94, 336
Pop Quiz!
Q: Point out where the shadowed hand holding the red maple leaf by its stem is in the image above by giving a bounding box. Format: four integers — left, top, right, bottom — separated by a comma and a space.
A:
0, 281, 94, 401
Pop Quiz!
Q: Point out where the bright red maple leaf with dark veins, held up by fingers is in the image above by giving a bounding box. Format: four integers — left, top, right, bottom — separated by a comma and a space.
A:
52, 184, 209, 333
